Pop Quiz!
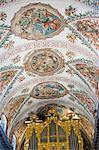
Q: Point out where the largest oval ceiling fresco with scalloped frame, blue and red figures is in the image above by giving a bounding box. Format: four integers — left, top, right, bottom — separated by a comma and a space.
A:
11, 3, 64, 40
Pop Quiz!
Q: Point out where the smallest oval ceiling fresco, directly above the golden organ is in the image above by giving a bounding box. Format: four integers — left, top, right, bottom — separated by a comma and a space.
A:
31, 82, 68, 99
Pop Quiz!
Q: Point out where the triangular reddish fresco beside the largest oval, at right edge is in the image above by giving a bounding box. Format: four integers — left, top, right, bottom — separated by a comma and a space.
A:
72, 17, 99, 49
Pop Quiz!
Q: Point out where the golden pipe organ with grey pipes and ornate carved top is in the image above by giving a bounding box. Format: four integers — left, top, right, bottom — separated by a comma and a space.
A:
24, 109, 83, 150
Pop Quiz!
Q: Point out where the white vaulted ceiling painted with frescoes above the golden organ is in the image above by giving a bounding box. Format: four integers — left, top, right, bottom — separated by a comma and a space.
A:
0, 0, 99, 148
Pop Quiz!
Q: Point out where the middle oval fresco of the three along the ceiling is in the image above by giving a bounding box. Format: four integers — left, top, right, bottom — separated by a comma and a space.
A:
24, 48, 64, 76
